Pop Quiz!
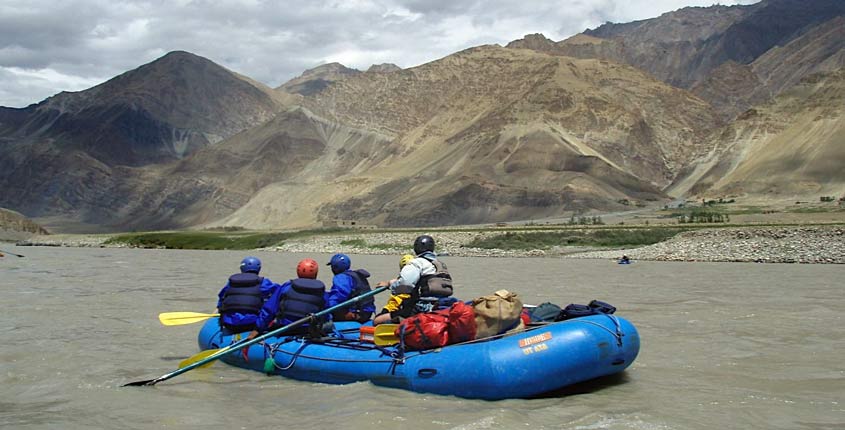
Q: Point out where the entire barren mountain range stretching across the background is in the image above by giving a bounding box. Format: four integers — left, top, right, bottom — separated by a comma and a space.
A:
0, 0, 845, 231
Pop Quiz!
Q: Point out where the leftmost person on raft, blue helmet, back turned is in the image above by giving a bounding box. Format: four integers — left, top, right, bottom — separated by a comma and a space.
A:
217, 257, 279, 332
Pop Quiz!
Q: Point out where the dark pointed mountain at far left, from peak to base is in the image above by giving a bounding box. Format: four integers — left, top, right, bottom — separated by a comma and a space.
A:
0, 52, 290, 228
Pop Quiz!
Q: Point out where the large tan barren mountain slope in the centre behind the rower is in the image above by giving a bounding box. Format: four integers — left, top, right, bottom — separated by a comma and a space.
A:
216, 46, 716, 227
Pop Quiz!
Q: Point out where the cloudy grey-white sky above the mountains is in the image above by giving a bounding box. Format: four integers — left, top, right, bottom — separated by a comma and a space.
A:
0, 0, 759, 107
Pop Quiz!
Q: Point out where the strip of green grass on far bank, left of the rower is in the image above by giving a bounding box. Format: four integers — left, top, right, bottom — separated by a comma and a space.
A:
106, 229, 340, 250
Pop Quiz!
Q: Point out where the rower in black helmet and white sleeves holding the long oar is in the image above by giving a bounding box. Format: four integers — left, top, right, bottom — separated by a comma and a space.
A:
373, 235, 455, 325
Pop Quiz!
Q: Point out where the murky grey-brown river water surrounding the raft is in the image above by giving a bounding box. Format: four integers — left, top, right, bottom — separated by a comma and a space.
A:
0, 245, 845, 430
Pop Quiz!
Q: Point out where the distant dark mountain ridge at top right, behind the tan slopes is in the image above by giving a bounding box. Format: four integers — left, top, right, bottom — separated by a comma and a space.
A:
508, 0, 845, 119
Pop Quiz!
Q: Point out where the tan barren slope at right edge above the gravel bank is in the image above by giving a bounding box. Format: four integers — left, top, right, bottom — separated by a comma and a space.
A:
669, 69, 845, 199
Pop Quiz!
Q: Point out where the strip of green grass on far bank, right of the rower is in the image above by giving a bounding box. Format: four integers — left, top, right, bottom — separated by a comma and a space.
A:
466, 228, 686, 250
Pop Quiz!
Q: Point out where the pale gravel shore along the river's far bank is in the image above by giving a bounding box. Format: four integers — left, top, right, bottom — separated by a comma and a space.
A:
14, 226, 845, 264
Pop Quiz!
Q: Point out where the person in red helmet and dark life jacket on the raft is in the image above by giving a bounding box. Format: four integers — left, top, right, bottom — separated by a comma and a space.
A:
247, 258, 326, 339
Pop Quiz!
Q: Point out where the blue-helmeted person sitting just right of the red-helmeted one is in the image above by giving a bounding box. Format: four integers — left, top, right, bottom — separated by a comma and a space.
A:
326, 254, 376, 323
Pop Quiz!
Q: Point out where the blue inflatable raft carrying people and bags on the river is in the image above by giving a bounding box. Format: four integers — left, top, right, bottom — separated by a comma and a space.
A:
199, 315, 640, 400
